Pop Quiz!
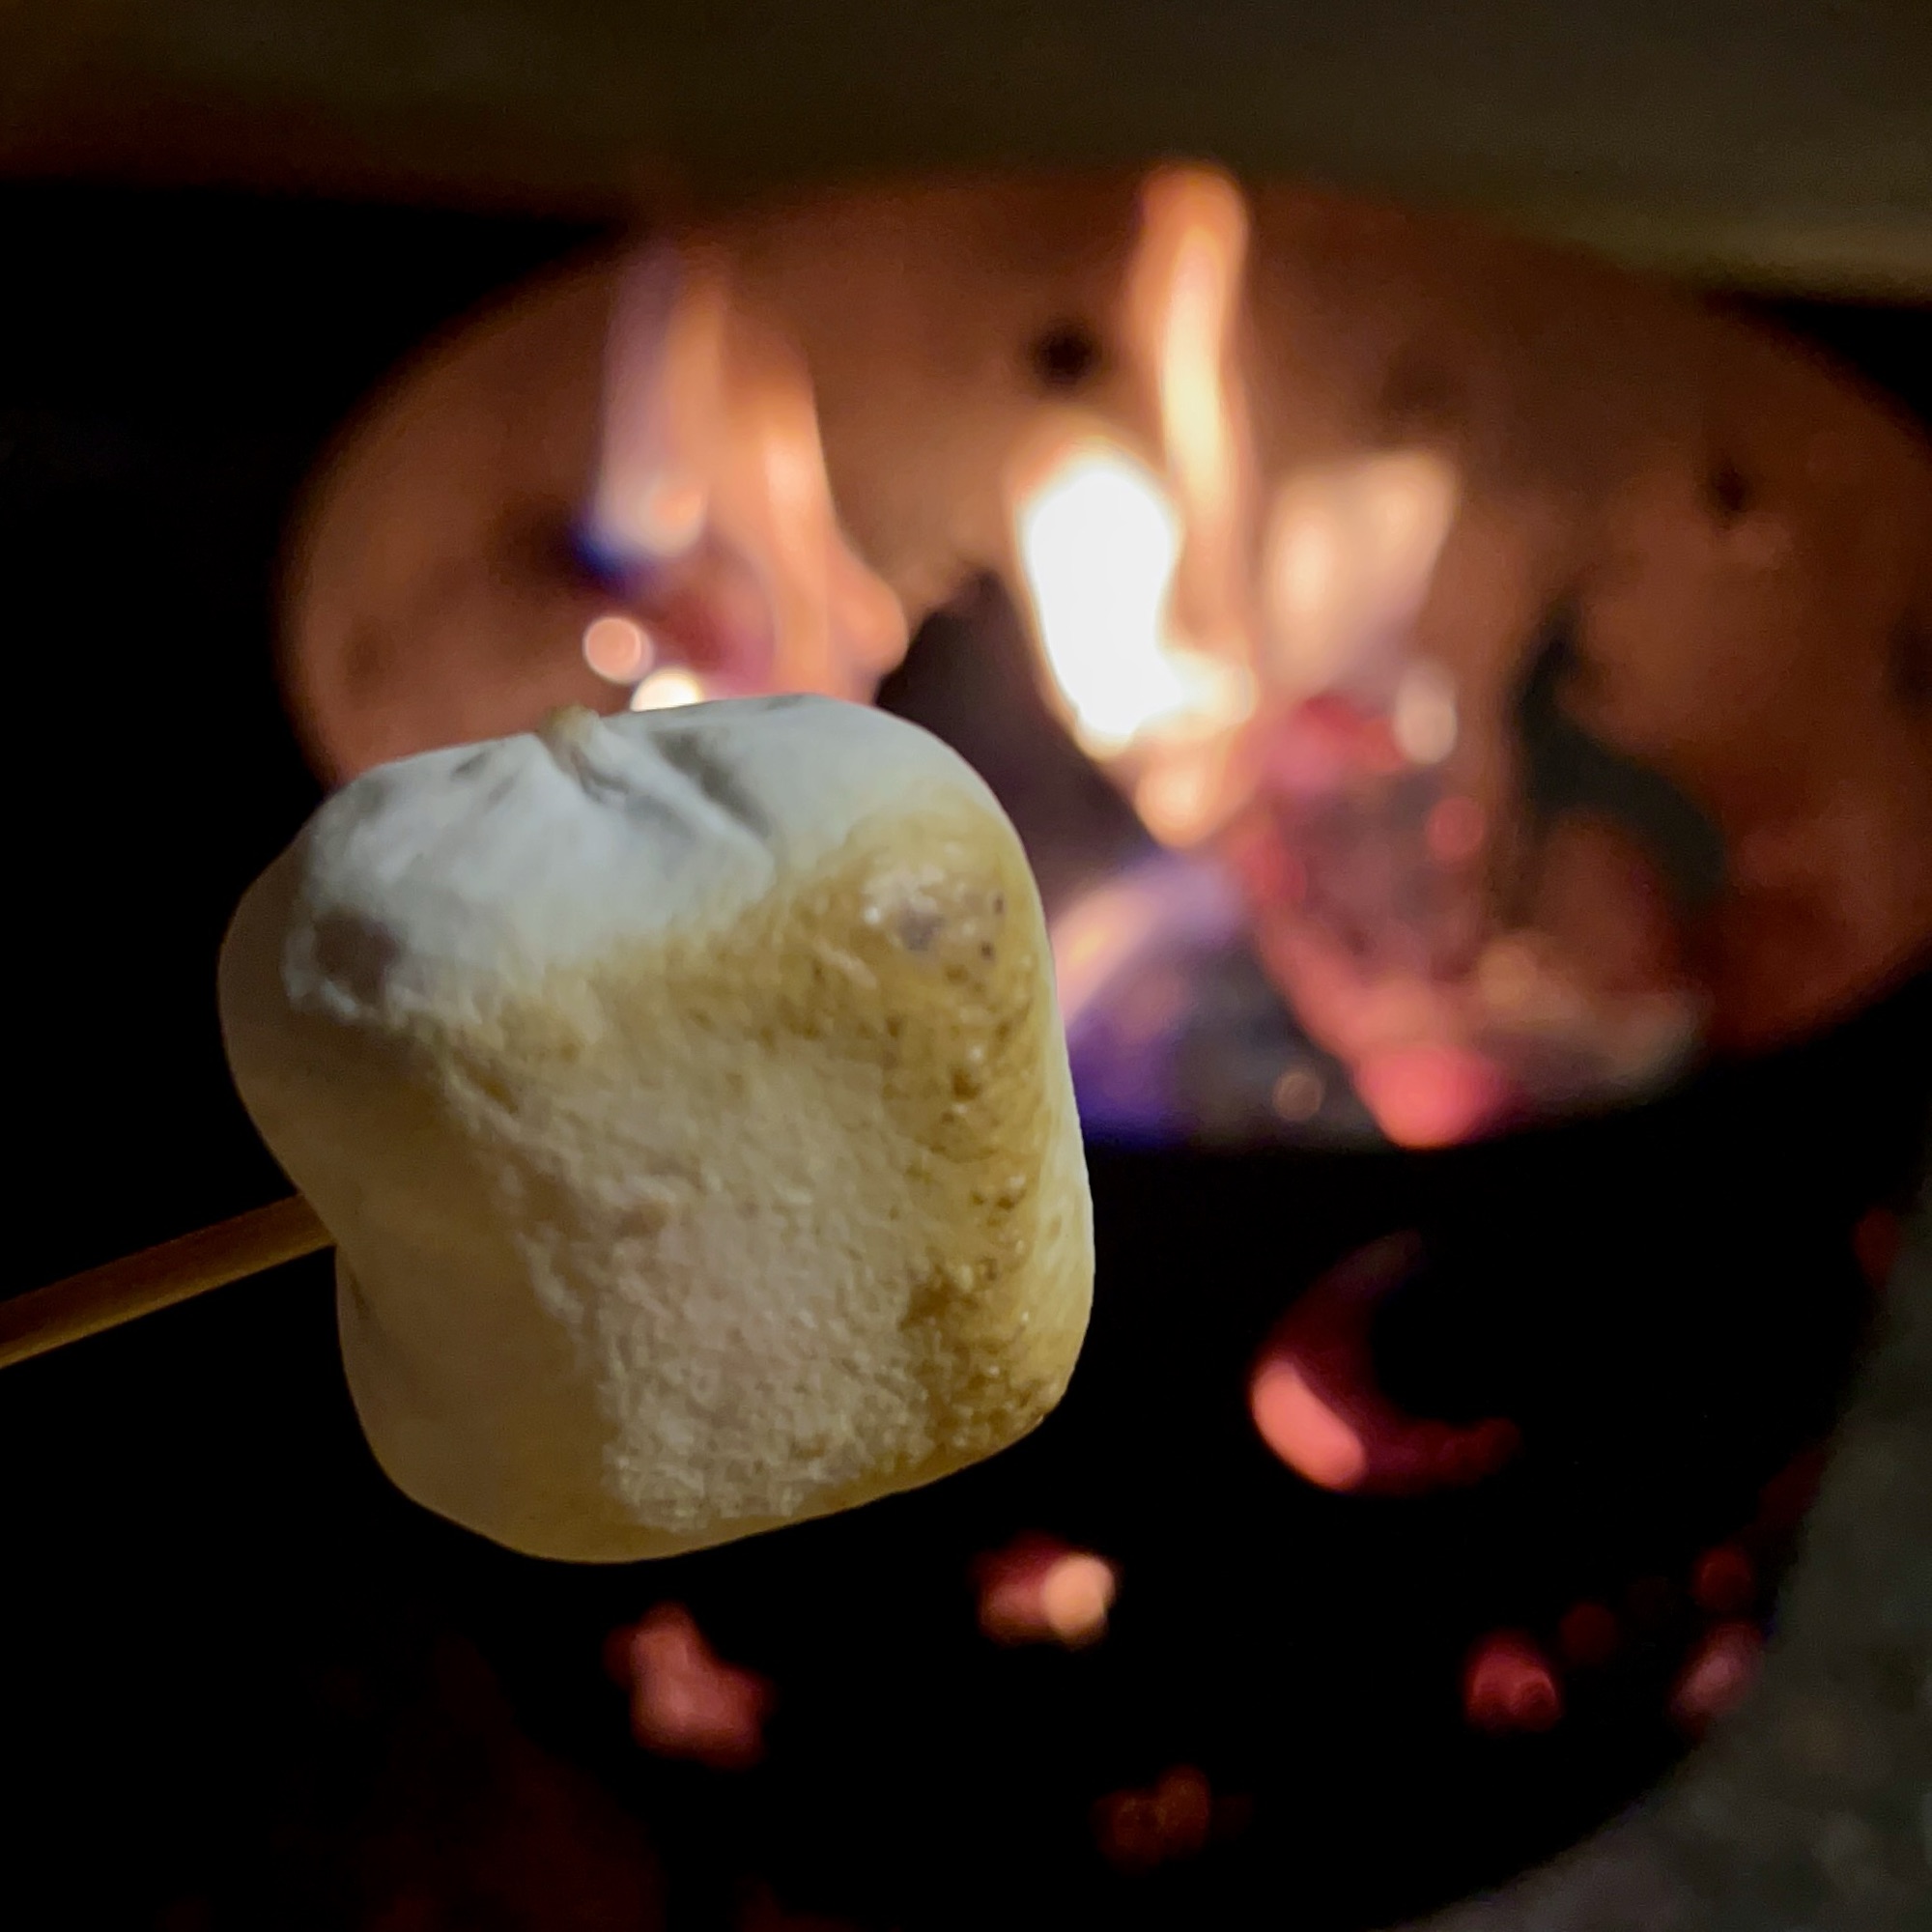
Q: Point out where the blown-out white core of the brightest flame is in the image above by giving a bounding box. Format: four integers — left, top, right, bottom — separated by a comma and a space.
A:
1018, 439, 1252, 757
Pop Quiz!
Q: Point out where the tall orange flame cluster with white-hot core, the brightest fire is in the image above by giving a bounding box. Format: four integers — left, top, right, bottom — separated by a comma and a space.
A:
1009, 168, 1457, 844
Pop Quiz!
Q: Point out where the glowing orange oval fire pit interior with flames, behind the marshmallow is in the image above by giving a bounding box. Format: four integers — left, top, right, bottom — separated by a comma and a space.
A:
292, 166, 1932, 1146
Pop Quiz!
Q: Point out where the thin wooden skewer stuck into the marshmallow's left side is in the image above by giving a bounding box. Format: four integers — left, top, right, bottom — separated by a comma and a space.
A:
0, 1194, 336, 1368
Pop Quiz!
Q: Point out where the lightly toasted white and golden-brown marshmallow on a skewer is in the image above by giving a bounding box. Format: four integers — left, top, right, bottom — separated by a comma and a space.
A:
220, 697, 1094, 1561
